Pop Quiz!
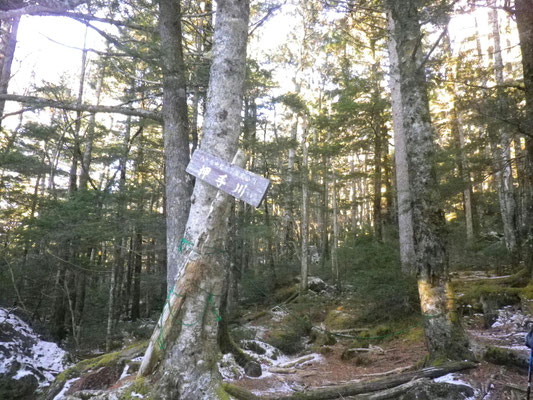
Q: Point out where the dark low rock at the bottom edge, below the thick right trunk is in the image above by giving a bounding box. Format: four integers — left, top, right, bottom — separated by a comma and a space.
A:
399, 380, 474, 400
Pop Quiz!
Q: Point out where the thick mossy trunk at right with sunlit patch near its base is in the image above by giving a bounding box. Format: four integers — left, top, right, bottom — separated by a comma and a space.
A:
386, 0, 468, 359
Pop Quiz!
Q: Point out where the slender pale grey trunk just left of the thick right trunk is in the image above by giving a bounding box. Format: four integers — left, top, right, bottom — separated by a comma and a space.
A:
388, 14, 415, 272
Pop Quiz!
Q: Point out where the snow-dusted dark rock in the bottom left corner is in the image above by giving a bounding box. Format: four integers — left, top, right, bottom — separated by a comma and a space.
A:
0, 308, 67, 388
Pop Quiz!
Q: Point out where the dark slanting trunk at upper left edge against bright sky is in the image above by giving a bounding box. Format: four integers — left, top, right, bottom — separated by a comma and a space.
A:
0, 16, 20, 128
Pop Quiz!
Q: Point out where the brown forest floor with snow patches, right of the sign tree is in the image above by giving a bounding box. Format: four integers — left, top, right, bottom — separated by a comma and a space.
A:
226, 271, 532, 400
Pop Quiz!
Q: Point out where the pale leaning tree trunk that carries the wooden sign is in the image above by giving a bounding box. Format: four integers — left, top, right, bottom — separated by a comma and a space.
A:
139, 0, 249, 400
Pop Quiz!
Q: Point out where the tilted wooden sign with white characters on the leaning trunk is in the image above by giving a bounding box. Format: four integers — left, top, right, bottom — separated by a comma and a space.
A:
186, 150, 270, 207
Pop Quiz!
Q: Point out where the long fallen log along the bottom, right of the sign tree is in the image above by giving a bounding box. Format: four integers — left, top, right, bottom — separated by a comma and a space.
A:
224, 361, 477, 400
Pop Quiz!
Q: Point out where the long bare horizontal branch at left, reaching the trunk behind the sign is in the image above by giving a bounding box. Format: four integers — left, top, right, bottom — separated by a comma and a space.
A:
0, 94, 163, 122
